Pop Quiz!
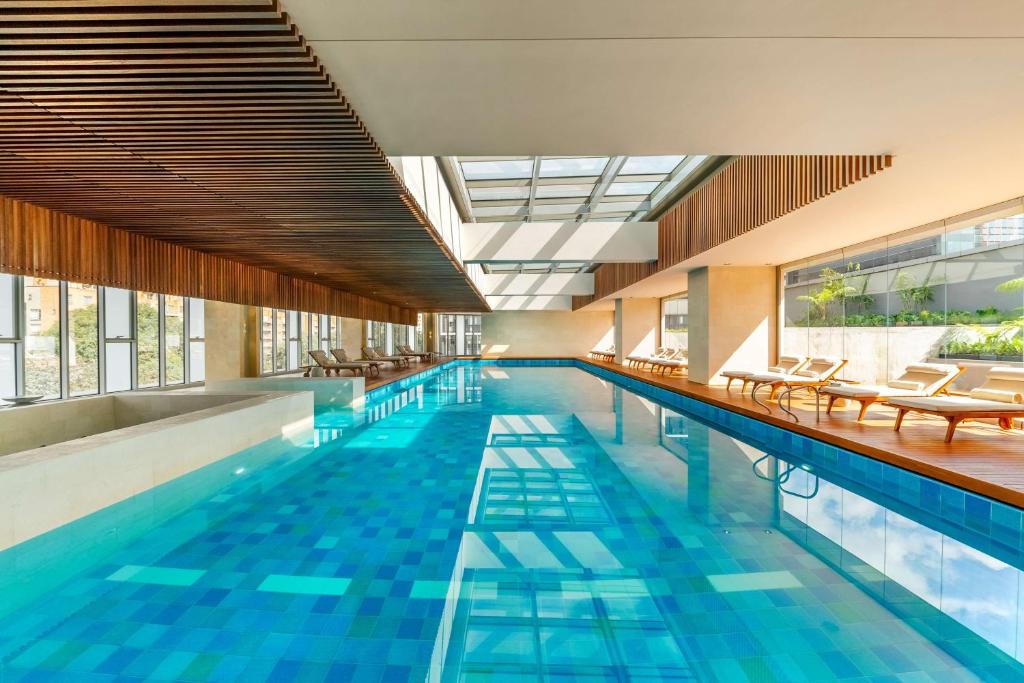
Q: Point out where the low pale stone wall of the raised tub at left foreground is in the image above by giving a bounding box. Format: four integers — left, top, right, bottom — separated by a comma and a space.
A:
0, 393, 313, 550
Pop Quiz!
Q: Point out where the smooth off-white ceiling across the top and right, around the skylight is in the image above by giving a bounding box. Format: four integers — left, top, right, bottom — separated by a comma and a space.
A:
283, 0, 1024, 303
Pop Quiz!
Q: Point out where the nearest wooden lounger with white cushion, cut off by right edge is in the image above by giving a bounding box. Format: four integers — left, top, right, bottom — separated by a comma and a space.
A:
889, 367, 1024, 443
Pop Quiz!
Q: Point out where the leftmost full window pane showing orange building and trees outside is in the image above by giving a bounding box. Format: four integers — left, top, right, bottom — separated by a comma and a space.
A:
25, 278, 60, 398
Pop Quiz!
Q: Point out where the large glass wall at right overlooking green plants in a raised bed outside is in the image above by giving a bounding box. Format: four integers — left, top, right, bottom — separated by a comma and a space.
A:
780, 200, 1024, 390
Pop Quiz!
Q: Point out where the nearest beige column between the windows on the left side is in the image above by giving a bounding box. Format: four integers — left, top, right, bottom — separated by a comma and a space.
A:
204, 300, 260, 382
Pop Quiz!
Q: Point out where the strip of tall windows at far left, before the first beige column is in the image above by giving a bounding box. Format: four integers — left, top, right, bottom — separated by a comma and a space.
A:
0, 273, 205, 399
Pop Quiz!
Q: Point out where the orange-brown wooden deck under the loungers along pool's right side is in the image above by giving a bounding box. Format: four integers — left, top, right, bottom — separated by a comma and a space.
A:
580, 358, 1024, 507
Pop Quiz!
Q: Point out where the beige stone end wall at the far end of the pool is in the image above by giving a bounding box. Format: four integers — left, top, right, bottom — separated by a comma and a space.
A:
480, 310, 613, 358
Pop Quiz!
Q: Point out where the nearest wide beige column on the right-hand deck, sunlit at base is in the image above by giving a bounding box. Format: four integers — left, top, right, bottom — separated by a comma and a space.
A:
687, 266, 778, 384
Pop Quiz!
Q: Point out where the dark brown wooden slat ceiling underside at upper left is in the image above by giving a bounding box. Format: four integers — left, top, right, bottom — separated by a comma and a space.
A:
0, 0, 487, 310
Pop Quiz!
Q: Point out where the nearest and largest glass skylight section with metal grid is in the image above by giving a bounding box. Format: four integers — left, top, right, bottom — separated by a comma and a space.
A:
453, 155, 710, 222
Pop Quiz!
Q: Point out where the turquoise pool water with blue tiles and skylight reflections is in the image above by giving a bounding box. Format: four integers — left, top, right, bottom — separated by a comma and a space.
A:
0, 364, 1024, 683
